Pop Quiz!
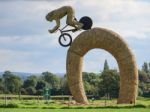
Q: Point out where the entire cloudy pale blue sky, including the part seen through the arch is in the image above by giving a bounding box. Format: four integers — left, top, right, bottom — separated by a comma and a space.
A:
0, 0, 150, 73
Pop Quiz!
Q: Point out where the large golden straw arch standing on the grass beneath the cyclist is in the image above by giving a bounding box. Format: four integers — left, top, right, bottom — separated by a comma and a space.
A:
67, 28, 138, 104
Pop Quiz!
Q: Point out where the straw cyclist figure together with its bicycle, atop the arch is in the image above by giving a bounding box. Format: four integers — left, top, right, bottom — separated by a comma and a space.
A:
46, 6, 93, 47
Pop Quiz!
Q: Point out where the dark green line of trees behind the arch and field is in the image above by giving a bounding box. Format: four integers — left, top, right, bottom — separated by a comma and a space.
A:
0, 60, 150, 98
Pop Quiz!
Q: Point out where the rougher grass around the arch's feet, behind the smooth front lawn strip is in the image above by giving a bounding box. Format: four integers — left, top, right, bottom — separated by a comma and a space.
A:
0, 98, 150, 109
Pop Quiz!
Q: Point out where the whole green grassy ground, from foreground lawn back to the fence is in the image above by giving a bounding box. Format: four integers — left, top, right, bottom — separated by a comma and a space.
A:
0, 96, 150, 112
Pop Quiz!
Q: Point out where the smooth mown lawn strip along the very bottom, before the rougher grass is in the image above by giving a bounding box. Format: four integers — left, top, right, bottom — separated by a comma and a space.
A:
0, 109, 150, 112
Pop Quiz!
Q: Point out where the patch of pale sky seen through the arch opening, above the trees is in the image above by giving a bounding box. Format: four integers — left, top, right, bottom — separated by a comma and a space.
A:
83, 49, 118, 73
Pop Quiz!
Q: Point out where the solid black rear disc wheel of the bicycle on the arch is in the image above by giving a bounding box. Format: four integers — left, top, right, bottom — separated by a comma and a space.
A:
79, 16, 93, 30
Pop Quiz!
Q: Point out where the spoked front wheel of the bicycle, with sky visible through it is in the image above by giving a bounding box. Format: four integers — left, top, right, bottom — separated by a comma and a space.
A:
58, 33, 72, 47
